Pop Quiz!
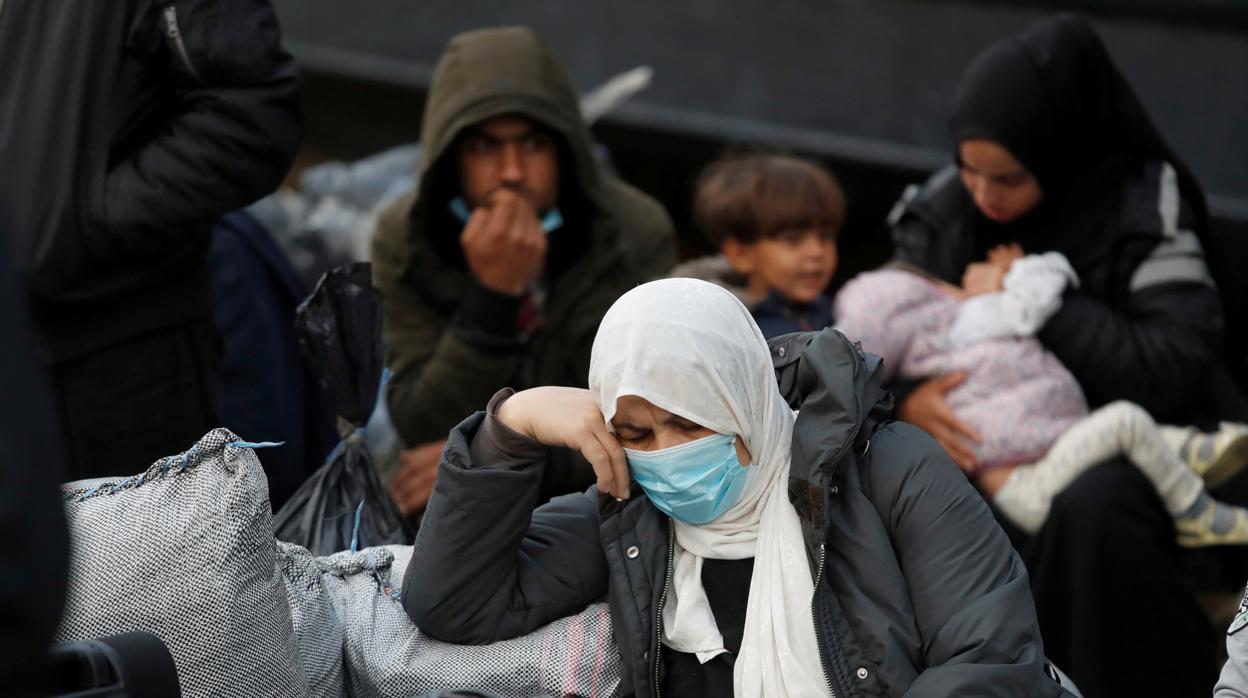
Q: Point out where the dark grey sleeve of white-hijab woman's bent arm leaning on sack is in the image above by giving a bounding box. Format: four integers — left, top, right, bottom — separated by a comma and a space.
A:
402, 413, 607, 644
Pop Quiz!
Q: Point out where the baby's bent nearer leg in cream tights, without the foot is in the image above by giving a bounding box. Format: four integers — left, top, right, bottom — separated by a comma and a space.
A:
995, 402, 1204, 533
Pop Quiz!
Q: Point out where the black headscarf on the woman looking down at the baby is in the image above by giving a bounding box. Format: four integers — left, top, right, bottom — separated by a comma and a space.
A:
951, 15, 1208, 276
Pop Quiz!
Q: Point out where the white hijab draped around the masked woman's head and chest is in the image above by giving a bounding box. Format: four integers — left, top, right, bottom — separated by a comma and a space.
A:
589, 278, 827, 698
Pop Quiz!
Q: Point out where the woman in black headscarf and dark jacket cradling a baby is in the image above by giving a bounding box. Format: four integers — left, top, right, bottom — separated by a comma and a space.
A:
894, 16, 1244, 696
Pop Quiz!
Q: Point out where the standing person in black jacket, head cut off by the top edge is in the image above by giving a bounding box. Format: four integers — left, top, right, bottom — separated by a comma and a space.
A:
0, 0, 301, 478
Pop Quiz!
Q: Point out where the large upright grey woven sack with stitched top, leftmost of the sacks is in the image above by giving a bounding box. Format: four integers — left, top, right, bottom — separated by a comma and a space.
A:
56, 430, 307, 698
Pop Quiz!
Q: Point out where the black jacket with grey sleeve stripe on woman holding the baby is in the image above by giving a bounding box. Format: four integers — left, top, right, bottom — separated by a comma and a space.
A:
890, 160, 1248, 423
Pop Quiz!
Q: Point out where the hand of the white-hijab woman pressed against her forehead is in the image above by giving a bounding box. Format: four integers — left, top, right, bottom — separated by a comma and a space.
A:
495, 387, 629, 499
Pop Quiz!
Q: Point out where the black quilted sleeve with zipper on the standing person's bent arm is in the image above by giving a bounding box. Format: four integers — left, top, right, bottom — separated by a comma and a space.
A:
97, 0, 302, 258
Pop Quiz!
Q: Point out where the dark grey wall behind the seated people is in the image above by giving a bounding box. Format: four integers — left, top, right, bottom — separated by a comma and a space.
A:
276, 0, 1248, 217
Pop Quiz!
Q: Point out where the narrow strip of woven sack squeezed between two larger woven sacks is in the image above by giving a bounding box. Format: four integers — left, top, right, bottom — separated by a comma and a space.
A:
277, 541, 347, 698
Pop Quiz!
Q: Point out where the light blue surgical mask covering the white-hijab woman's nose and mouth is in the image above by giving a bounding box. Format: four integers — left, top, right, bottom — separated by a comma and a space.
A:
624, 433, 751, 526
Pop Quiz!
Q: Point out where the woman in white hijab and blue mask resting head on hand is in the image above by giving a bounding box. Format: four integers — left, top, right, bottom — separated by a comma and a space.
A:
403, 278, 1063, 698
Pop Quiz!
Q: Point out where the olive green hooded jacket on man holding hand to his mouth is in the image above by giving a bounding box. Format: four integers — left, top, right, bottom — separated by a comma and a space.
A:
373, 27, 675, 464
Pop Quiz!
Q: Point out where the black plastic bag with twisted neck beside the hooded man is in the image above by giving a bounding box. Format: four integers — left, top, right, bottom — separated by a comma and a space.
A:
273, 263, 414, 556
